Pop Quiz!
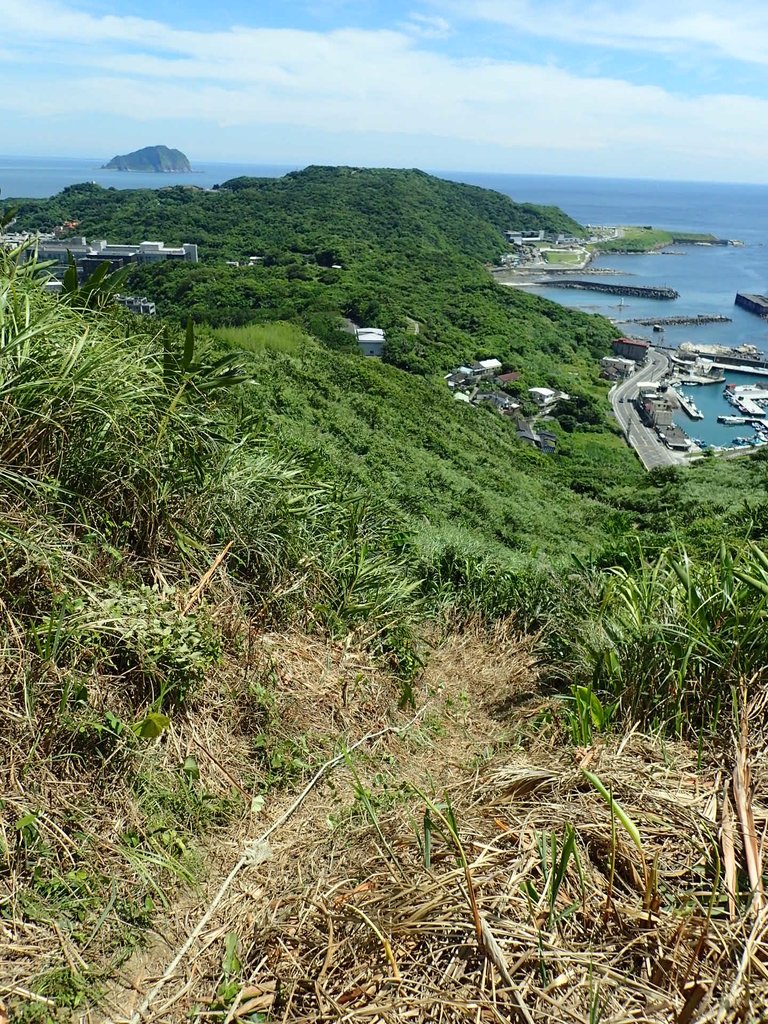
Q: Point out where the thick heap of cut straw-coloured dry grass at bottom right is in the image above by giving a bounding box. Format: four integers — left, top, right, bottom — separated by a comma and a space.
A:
186, 736, 768, 1024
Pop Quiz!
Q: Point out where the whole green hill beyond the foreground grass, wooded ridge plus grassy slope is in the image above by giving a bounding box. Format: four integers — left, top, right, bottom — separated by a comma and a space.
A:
10, 167, 765, 560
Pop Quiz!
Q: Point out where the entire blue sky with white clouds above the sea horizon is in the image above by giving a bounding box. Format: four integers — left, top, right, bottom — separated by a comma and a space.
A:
0, 0, 768, 182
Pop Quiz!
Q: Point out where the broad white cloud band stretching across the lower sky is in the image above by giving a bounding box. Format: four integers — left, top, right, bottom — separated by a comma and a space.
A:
0, 0, 768, 180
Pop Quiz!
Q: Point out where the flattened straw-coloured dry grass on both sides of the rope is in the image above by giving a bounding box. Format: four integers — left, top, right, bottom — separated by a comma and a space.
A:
2, 629, 768, 1024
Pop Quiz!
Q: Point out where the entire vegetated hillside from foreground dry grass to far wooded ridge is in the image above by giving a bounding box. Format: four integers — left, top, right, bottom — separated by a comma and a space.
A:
0, 169, 768, 1024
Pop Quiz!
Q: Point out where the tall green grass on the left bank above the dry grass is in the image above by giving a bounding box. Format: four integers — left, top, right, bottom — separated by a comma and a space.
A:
0, 245, 418, 679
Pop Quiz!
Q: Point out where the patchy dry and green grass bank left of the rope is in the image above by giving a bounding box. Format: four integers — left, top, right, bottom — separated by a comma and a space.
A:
0, 595, 428, 1021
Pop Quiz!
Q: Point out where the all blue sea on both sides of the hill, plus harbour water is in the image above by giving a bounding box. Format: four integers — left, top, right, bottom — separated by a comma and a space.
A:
0, 157, 768, 443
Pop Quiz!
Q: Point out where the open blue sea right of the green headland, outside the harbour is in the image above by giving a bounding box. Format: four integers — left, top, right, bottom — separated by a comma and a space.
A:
451, 174, 768, 350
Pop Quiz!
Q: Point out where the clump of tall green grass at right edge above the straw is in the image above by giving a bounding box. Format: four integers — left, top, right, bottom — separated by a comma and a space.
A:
574, 543, 768, 738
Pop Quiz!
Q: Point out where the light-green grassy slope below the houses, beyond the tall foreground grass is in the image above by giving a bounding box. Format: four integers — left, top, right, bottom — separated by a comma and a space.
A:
210, 328, 640, 556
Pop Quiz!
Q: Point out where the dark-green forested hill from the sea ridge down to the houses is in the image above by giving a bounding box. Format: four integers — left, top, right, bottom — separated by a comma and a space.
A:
17, 167, 602, 375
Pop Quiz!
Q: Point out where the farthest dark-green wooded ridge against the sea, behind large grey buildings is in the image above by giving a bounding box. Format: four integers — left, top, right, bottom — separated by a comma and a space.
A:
10, 167, 581, 260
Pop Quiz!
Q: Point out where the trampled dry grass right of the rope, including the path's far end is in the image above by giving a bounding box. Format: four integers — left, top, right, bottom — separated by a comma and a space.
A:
97, 622, 768, 1024
